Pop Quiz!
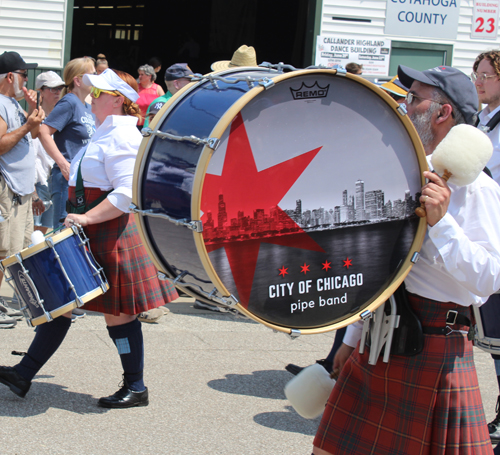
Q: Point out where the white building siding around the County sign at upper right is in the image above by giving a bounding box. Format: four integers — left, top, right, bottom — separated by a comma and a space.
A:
320, 0, 500, 74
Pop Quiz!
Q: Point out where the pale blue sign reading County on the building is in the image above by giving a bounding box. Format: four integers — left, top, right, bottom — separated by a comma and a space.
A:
385, 0, 460, 39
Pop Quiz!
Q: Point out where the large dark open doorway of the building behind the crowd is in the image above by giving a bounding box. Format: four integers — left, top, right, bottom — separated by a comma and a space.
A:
71, 0, 316, 76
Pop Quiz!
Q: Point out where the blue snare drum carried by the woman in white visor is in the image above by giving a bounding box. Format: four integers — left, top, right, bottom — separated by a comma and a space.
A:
0, 226, 109, 326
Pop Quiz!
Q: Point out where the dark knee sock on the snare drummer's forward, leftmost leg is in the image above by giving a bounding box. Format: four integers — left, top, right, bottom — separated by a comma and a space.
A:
14, 316, 71, 381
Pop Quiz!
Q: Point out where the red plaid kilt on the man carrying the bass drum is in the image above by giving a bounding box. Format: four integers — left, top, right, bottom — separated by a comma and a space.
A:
314, 294, 493, 455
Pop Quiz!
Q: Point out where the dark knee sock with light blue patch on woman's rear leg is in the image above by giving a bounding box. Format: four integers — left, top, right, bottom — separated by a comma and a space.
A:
108, 319, 146, 392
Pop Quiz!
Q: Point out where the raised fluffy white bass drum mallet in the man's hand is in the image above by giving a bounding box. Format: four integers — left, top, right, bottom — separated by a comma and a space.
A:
415, 124, 493, 217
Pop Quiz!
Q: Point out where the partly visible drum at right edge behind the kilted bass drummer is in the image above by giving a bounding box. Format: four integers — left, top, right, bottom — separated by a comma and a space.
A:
472, 294, 500, 355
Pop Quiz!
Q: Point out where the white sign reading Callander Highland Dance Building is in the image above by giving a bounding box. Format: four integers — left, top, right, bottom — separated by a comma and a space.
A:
316, 35, 391, 76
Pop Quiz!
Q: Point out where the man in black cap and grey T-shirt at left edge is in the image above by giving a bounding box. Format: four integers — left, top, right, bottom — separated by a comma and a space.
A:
0, 52, 45, 292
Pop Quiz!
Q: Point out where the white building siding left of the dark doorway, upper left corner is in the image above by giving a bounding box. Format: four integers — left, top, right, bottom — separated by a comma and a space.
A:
0, 0, 67, 68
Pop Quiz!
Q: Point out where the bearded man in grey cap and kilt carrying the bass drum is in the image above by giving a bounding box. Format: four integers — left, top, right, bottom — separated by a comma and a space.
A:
313, 66, 500, 455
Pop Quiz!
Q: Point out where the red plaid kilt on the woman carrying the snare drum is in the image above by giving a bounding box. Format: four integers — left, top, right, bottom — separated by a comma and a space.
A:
69, 187, 179, 316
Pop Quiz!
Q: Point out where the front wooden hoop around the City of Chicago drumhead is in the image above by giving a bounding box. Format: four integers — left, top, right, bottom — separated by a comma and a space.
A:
191, 69, 428, 334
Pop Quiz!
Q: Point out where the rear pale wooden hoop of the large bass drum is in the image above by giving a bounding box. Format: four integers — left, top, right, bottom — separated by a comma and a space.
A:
132, 66, 279, 285
